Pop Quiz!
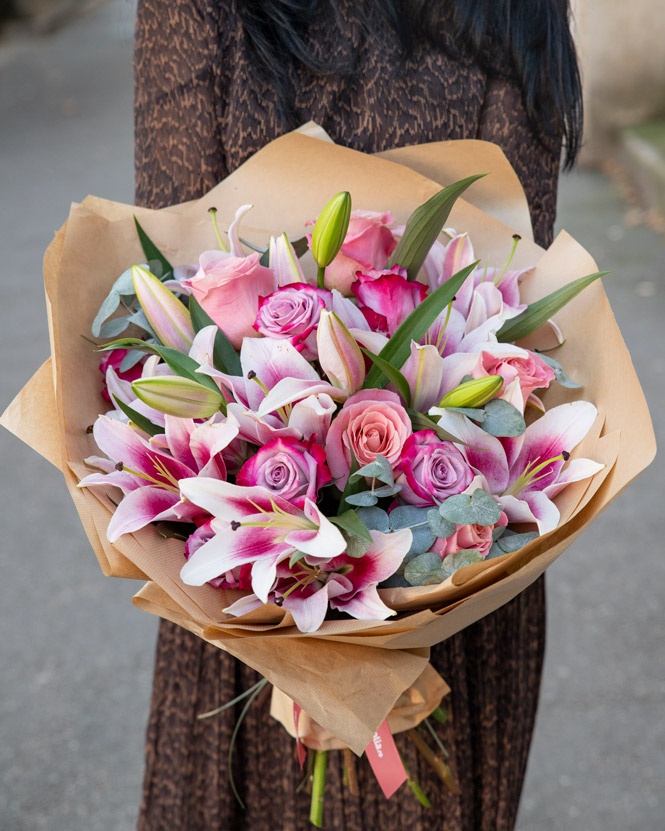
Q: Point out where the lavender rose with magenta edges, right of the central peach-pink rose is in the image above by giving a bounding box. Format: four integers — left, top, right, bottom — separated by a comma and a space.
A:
397, 430, 474, 508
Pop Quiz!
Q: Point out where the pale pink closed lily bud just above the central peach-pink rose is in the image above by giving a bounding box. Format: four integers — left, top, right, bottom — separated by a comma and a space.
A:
316, 309, 365, 396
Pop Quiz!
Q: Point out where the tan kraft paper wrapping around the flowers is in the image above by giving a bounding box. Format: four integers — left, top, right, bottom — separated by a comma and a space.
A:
1, 130, 655, 754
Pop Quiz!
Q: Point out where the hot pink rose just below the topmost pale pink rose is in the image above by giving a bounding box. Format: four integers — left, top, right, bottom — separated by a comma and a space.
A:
351, 266, 427, 336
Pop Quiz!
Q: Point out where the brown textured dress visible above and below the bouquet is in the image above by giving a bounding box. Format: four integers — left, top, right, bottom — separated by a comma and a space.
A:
135, 0, 560, 831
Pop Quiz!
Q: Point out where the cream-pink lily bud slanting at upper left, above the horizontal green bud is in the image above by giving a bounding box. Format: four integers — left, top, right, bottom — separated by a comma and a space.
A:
132, 265, 194, 352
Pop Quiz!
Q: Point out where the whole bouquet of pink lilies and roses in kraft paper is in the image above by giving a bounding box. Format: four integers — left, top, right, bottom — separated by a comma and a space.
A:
3, 127, 653, 822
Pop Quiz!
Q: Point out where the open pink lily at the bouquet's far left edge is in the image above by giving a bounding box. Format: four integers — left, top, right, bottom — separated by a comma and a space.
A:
78, 415, 238, 542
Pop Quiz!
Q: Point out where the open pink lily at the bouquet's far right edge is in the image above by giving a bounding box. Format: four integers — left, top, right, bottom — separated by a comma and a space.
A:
430, 401, 604, 534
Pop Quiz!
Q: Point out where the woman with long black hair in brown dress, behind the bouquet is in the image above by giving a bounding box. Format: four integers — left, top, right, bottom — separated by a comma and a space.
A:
135, 0, 580, 831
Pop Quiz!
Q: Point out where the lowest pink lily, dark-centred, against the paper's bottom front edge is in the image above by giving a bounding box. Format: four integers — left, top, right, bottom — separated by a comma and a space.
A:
224, 528, 412, 632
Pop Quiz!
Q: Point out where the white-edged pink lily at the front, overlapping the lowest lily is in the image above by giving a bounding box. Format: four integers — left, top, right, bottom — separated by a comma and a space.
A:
180, 476, 346, 603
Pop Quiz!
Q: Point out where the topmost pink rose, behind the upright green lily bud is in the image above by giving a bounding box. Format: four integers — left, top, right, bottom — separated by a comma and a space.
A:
312, 211, 397, 296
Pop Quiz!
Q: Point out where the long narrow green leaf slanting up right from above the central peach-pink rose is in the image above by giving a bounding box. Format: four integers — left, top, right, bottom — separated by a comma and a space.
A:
363, 261, 478, 389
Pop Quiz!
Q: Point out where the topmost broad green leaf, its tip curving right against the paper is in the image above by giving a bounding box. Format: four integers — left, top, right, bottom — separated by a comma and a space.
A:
388, 173, 487, 280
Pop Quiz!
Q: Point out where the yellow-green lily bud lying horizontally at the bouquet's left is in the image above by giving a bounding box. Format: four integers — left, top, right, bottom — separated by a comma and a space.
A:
132, 375, 224, 418
